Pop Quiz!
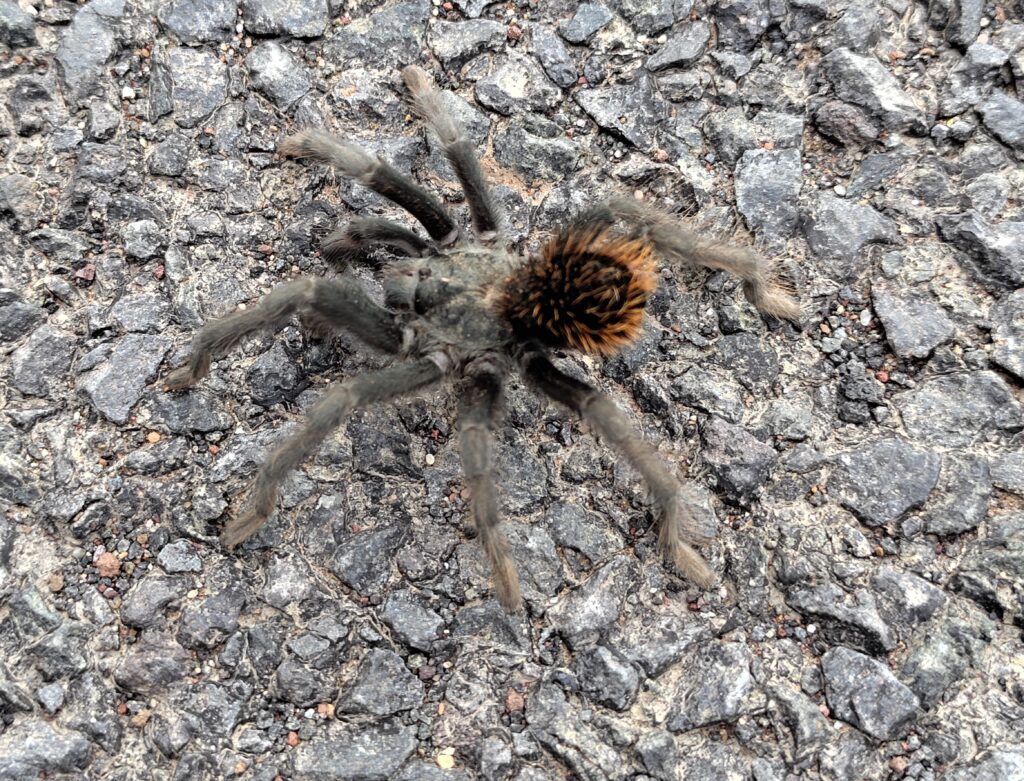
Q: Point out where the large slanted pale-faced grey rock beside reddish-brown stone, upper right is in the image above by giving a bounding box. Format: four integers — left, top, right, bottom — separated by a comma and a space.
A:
821, 48, 928, 135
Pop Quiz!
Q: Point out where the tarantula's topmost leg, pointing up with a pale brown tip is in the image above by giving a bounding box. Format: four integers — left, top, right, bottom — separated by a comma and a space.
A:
401, 66, 501, 241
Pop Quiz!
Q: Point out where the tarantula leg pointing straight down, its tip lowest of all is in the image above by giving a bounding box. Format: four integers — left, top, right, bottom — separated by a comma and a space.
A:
459, 364, 520, 613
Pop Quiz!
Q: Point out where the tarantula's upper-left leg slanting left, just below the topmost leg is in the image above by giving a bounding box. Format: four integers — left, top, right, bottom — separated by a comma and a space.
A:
279, 130, 459, 246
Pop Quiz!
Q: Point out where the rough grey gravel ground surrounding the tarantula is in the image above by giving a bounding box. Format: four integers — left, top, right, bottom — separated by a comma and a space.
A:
0, 0, 1024, 781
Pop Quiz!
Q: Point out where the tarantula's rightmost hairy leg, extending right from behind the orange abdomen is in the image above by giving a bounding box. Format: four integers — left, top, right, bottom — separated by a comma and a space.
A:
577, 198, 800, 326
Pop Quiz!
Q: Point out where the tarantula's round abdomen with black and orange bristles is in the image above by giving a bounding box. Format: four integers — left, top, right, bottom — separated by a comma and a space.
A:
501, 230, 656, 356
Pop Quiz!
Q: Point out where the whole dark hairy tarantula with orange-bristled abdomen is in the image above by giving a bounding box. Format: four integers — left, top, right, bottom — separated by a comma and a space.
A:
165, 66, 800, 612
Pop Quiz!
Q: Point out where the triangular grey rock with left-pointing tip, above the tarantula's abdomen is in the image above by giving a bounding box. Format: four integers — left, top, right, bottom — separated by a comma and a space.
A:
573, 73, 668, 149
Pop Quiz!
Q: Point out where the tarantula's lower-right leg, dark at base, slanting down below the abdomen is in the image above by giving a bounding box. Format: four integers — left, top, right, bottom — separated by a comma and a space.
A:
520, 350, 717, 589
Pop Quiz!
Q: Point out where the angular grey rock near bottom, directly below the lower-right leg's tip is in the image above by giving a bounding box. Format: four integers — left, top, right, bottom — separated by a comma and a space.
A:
666, 642, 755, 732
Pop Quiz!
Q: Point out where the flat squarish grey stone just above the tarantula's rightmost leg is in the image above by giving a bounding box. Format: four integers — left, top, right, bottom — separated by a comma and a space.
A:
735, 149, 803, 246
